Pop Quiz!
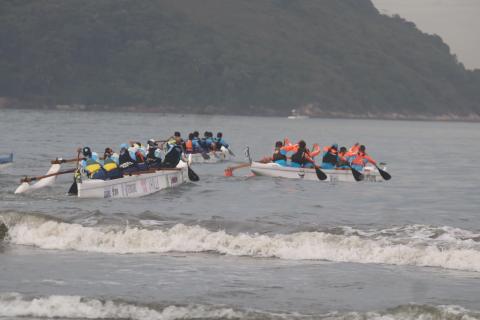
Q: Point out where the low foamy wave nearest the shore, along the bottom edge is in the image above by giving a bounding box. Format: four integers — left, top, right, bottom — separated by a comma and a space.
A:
0, 293, 480, 320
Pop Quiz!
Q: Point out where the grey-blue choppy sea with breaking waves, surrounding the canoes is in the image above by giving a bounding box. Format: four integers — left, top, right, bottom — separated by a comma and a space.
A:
0, 111, 480, 319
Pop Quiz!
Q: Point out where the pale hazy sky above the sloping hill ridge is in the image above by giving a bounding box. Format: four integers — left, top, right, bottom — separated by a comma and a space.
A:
372, 0, 480, 69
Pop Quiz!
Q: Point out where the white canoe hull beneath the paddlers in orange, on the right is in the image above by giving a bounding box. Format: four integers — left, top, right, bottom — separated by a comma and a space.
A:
250, 162, 384, 182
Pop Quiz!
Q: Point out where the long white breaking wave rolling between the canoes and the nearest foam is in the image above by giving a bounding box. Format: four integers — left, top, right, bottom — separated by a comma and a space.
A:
0, 214, 480, 272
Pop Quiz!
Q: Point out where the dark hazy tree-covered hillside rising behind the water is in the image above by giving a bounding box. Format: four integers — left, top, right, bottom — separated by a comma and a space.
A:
0, 0, 480, 117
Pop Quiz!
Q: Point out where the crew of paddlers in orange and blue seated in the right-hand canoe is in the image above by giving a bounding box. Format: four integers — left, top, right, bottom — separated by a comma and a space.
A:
264, 139, 377, 171
